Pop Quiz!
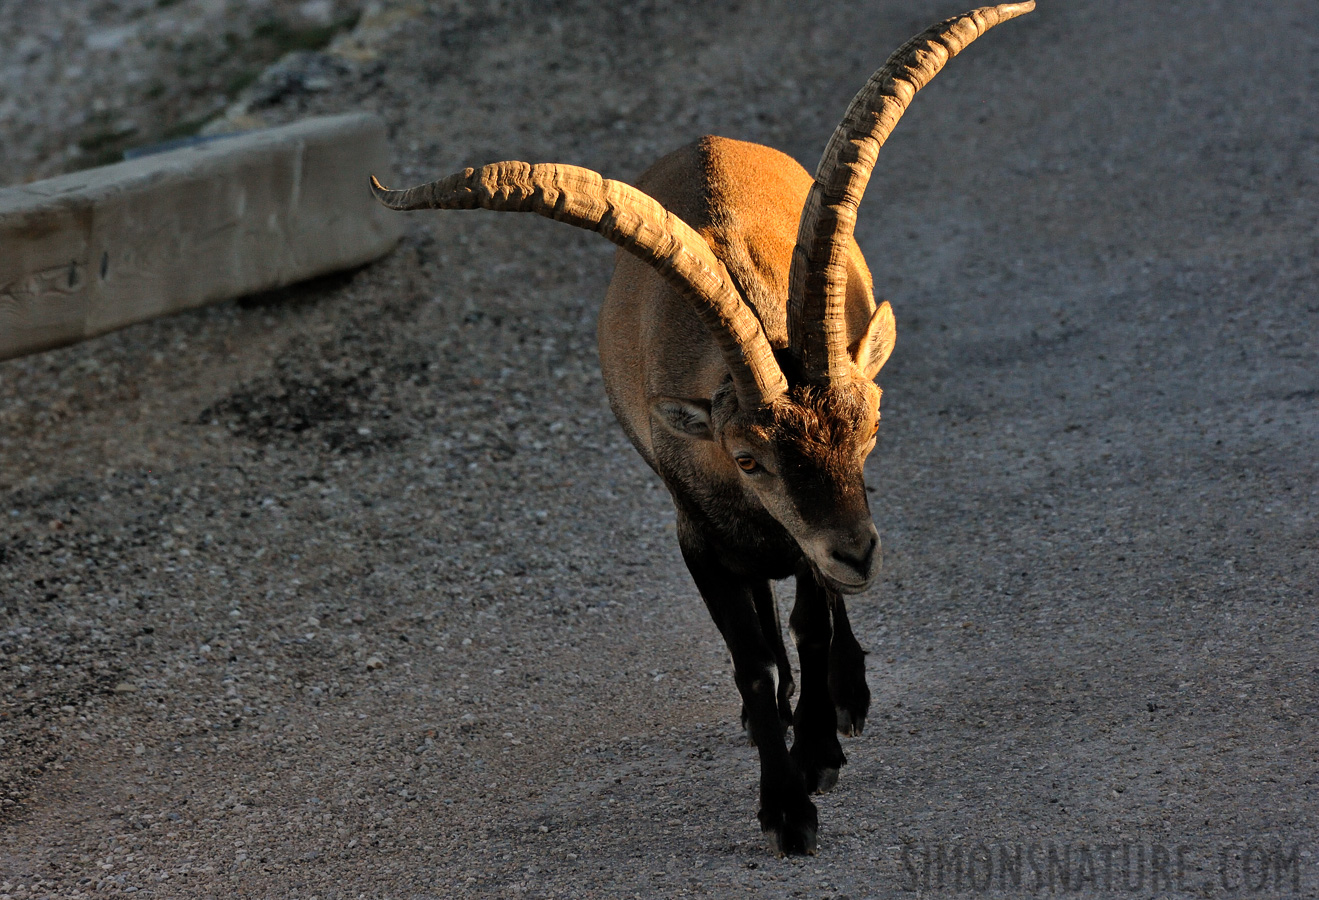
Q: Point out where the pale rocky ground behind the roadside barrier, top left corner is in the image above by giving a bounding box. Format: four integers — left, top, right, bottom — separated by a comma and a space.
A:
0, 0, 361, 185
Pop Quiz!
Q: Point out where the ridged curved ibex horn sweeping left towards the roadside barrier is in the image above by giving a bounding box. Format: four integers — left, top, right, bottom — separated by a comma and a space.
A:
371, 162, 787, 408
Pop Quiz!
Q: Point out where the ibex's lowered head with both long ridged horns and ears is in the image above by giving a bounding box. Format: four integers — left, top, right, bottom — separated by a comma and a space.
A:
372, 3, 1034, 591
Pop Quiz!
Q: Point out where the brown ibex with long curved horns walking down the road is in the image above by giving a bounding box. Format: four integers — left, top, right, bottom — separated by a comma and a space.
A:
372, 3, 1034, 854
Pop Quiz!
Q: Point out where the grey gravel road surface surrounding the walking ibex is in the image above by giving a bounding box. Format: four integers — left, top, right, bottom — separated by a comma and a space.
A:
0, 0, 1319, 899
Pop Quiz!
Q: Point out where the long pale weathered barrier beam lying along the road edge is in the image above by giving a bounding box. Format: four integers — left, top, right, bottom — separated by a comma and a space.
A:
0, 113, 402, 359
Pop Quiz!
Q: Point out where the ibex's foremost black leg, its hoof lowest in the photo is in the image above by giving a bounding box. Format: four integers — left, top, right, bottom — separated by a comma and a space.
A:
682, 541, 819, 855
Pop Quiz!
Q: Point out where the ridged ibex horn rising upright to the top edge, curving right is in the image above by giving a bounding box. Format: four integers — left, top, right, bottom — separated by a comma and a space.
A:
787, 0, 1035, 381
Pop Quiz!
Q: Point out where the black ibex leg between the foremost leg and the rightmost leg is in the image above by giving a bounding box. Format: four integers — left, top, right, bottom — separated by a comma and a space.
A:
789, 563, 847, 792
